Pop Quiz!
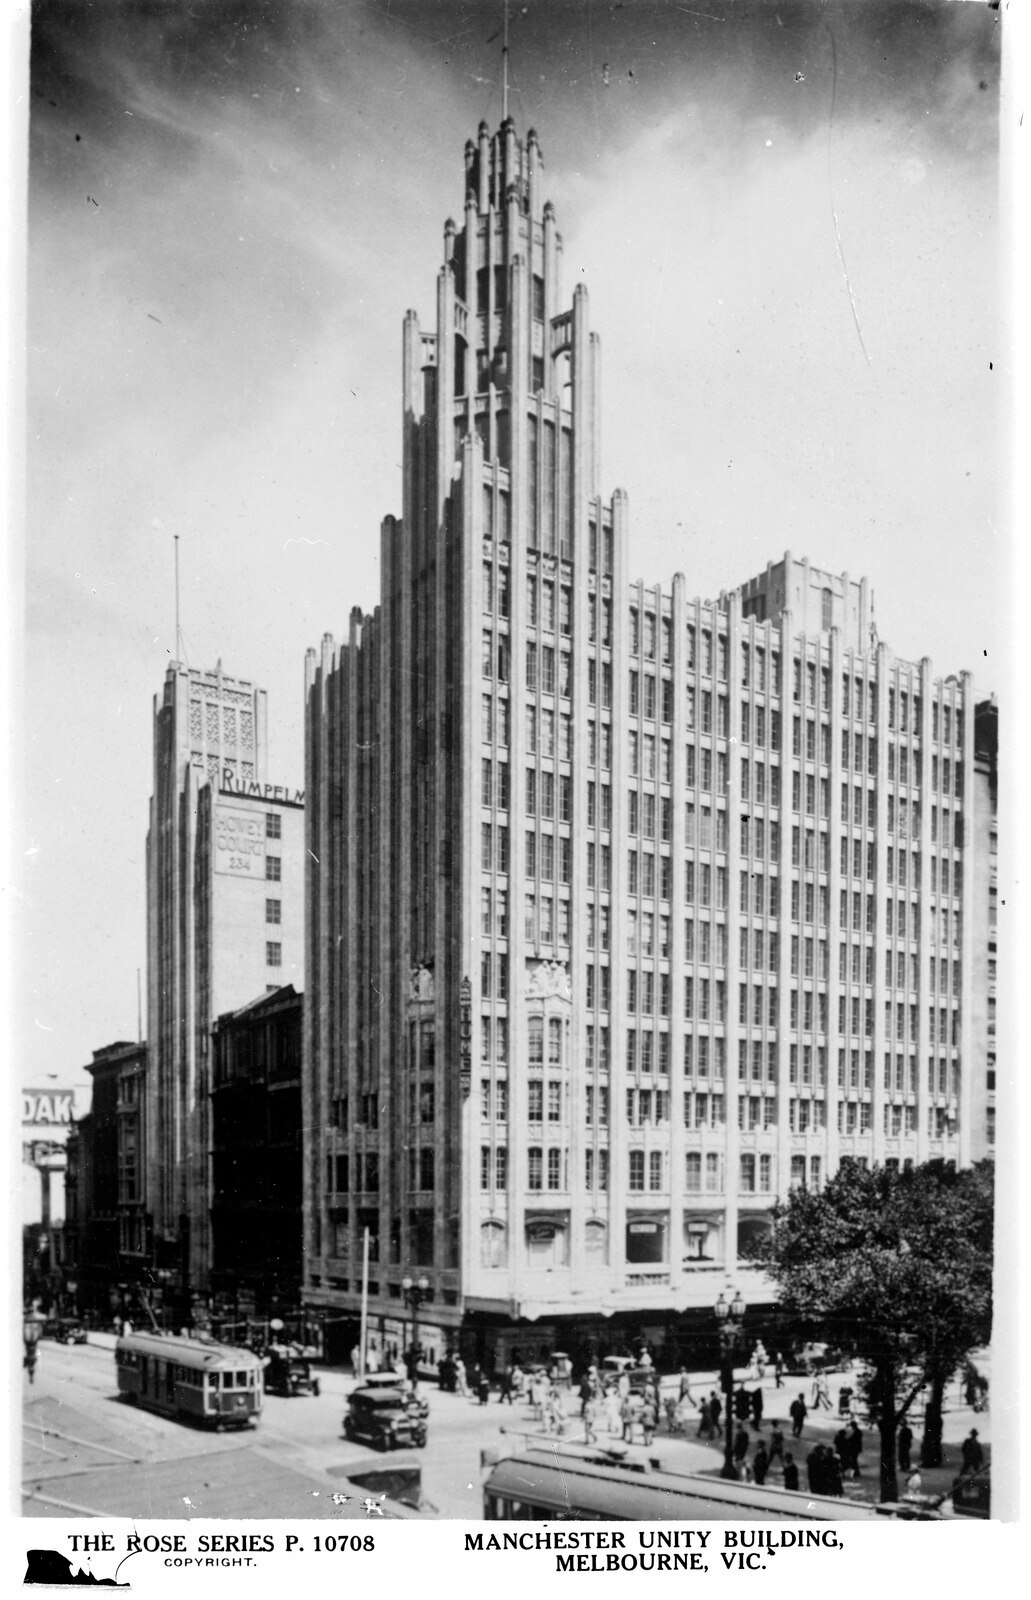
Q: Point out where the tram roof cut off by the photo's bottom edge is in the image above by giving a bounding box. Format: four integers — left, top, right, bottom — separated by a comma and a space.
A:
483, 1446, 879, 1522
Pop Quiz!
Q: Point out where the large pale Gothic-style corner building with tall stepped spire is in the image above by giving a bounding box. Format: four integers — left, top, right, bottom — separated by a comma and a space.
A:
304, 120, 973, 1360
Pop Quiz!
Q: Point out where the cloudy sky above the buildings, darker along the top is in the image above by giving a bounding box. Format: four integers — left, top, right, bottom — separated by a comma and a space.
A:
11, 0, 1007, 1085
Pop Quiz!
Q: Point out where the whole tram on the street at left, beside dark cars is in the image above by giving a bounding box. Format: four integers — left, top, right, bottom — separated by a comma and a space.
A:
115, 1333, 264, 1432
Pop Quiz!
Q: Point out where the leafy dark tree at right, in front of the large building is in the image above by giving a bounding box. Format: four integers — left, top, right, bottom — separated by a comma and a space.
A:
754, 1160, 993, 1501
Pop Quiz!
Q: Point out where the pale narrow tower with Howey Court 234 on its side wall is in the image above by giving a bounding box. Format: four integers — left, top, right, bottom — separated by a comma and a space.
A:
146, 662, 304, 1318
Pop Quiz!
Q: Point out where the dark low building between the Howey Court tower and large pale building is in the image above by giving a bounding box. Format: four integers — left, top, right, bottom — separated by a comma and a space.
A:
211, 984, 303, 1322
